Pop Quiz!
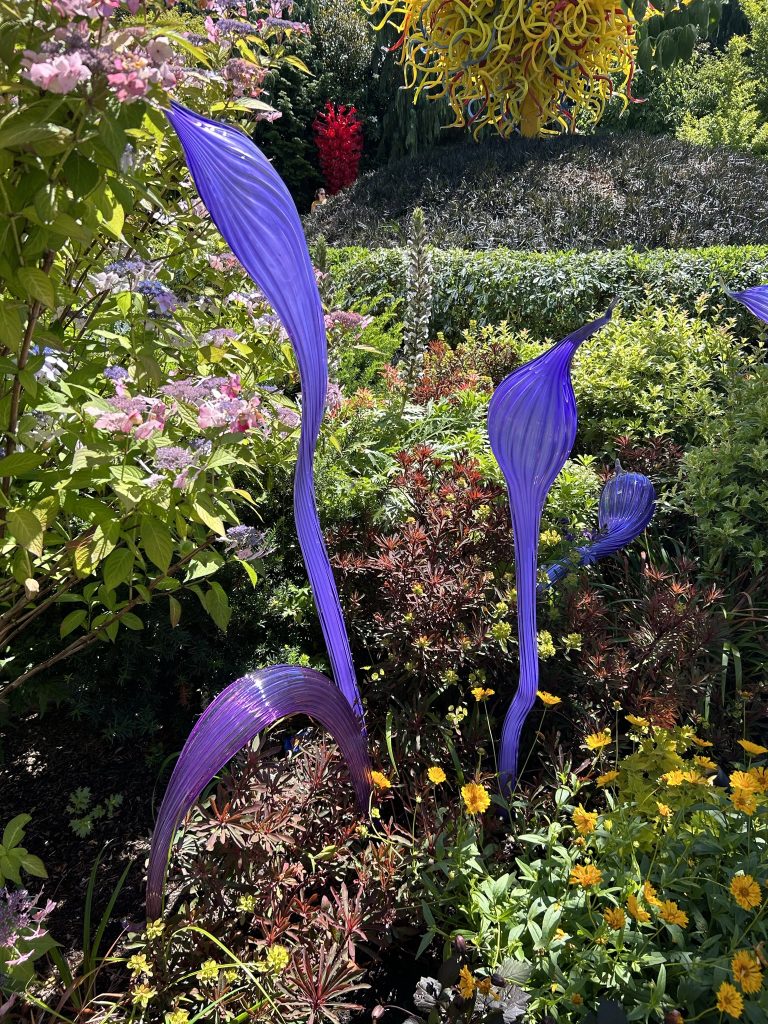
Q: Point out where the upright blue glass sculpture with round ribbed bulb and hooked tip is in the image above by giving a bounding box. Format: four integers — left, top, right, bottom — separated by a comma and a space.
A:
488, 306, 613, 790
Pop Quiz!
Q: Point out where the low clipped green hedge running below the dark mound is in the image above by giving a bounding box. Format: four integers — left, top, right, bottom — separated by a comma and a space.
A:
329, 245, 768, 340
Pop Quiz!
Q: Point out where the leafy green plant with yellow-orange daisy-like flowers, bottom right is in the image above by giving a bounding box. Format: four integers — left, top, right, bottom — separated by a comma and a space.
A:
417, 718, 768, 1024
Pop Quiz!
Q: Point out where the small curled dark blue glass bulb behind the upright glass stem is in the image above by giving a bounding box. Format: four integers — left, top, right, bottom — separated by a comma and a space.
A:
540, 459, 656, 590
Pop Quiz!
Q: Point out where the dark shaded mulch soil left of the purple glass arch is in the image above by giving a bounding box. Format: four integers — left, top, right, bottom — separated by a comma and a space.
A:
0, 712, 168, 950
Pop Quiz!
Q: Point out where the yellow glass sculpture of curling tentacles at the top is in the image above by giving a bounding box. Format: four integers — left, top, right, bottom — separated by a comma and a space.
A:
364, 0, 689, 137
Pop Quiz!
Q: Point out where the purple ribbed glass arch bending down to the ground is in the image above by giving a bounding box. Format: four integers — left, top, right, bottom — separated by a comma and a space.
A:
146, 665, 371, 920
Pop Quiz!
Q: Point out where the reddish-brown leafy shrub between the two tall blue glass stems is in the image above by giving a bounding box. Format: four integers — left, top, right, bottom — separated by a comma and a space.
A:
329, 444, 514, 681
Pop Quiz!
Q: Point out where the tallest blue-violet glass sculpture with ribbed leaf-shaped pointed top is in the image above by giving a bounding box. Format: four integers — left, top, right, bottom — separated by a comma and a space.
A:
166, 102, 362, 720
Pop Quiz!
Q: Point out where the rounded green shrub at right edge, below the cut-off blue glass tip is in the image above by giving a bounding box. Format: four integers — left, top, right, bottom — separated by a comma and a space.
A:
682, 364, 768, 579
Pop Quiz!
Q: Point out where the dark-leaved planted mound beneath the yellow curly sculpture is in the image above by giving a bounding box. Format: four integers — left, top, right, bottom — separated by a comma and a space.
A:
306, 133, 768, 252
